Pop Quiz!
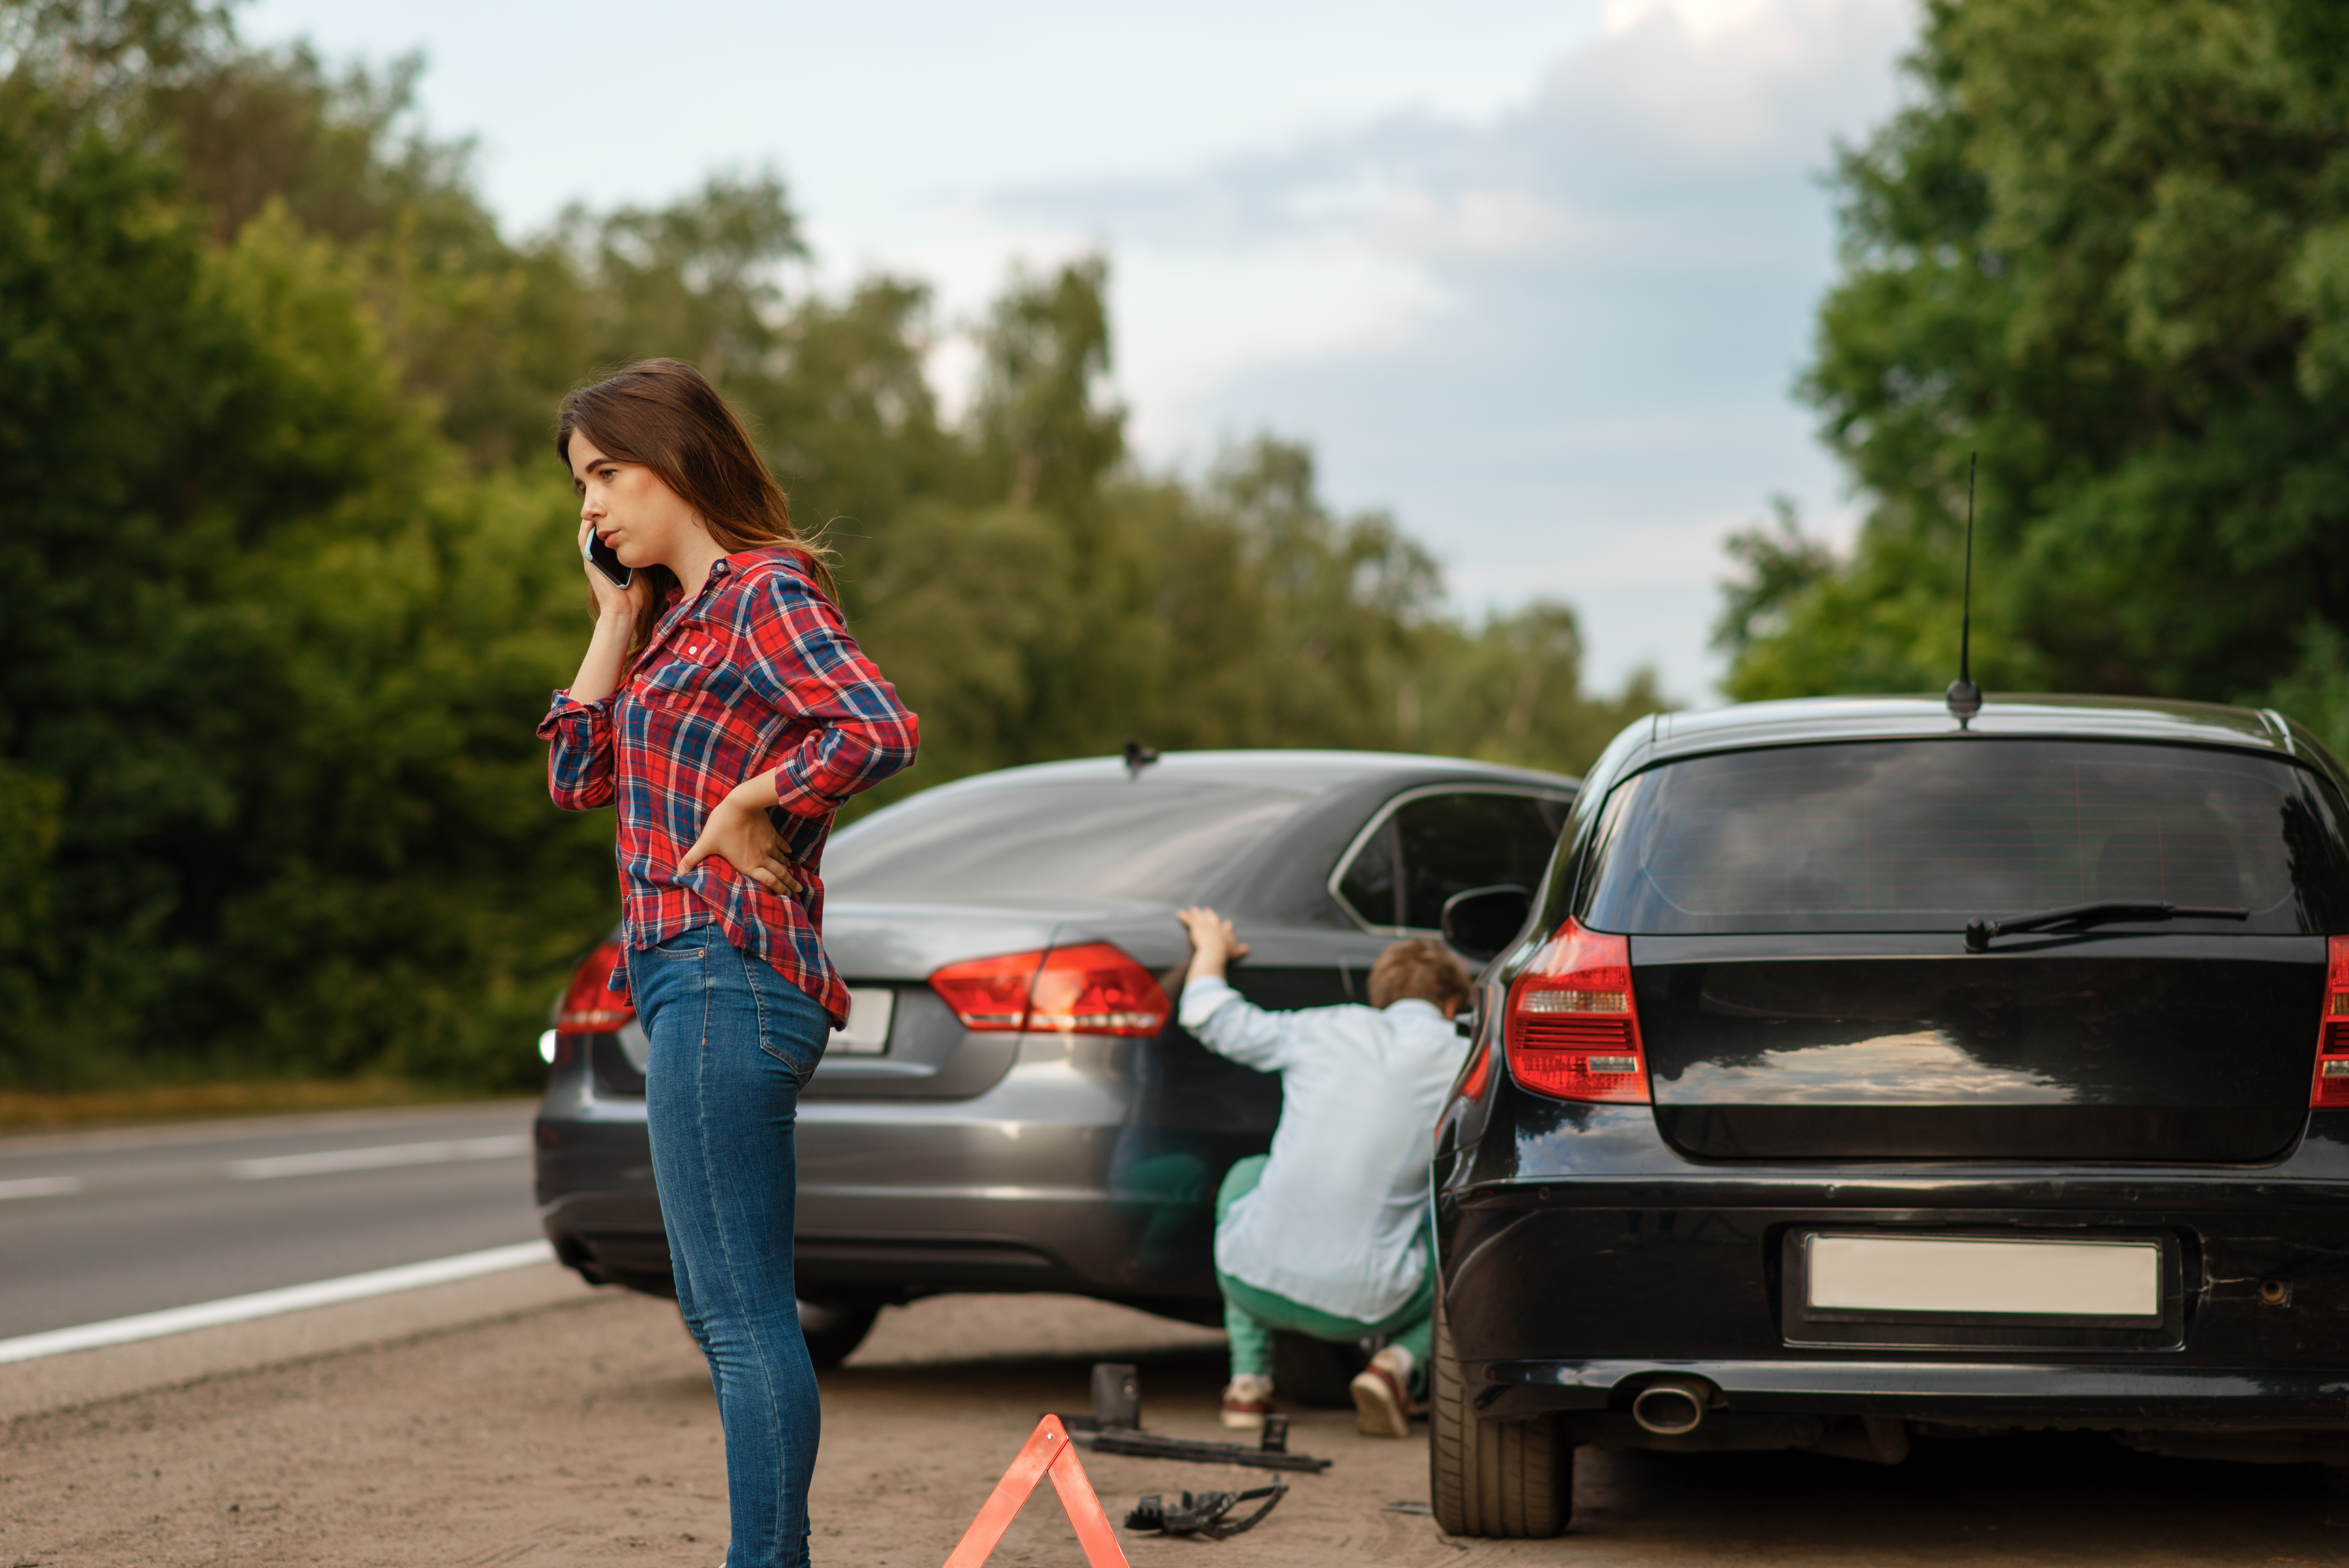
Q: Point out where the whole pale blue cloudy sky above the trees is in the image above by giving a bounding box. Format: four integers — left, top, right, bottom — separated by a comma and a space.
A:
240, 0, 1914, 702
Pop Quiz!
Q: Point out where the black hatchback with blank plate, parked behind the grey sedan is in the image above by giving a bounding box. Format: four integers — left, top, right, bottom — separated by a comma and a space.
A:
1431, 697, 2349, 1535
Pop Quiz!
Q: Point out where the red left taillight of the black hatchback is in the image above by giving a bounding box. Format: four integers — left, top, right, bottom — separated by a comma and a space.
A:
1501, 920, 1647, 1106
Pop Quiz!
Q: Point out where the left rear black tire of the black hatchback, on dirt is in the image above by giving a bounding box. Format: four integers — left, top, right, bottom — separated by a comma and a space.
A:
1428, 1291, 1574, 1540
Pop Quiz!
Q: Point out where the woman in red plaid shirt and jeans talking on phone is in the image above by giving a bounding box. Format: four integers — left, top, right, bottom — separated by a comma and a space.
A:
538, 359, 918, 1568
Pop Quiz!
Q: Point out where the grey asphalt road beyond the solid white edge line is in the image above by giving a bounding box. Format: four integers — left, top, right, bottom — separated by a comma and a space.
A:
0, 1101, 540, 1338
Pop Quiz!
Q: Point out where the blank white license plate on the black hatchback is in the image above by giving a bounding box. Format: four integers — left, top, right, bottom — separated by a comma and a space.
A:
1804, 1235, 2161, 1322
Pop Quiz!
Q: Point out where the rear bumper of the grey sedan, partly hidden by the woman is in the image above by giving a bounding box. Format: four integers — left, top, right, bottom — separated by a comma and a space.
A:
538, 1037, 1266, 1319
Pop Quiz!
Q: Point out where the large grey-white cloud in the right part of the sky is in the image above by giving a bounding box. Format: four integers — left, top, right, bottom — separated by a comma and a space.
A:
968, 0, 1912, 697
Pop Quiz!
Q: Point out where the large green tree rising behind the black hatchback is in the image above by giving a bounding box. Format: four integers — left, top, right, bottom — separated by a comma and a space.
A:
1727, 0, 2349, 737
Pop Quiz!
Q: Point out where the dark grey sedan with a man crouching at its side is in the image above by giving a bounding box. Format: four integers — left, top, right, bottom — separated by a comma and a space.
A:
538, 751, 1574, 1370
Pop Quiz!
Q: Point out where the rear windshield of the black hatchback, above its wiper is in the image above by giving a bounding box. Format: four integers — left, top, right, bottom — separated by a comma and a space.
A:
1579, 739, 2349, 934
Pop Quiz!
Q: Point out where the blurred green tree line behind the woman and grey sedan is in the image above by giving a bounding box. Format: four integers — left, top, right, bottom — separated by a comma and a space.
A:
0, 0, 1661, 1087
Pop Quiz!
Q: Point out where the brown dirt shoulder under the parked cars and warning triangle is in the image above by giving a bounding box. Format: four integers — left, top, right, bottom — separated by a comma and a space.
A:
14, 1286, 2349, 1568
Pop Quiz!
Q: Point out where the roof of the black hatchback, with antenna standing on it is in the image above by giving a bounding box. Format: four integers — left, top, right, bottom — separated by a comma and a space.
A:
1640, 693, 2314, 765
